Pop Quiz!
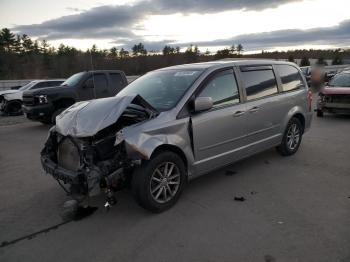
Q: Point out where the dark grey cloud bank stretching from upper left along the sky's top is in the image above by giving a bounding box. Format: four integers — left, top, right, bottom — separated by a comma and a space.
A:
13, 0, 300, 40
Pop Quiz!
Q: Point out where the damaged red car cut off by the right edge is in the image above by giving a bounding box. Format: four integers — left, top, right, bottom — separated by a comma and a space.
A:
316, 71, 350, 117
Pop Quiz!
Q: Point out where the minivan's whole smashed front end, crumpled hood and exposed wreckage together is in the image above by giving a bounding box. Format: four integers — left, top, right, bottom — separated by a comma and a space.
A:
41, 96, 157, 204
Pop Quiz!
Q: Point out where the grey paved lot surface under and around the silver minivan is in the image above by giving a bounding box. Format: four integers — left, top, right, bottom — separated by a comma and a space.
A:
0, 113, 350, 262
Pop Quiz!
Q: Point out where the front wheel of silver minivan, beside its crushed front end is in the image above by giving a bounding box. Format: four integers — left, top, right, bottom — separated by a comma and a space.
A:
132, 151, 186, 213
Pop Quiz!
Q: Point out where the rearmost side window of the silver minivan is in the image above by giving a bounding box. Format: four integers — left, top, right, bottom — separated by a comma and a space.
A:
276, 65, 304, 92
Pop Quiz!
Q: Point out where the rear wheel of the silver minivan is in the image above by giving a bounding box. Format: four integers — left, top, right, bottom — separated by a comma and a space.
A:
277, 117, 304, 156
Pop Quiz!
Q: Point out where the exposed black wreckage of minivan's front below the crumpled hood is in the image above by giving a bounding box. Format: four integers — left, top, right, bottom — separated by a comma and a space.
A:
41, 131, 137, 199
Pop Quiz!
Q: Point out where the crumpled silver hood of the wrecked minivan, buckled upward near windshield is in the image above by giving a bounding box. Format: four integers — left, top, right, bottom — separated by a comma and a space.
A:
56, 95, 157, 137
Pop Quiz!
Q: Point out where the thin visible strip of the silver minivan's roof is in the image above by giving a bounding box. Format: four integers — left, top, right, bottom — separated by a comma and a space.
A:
158, 59, 296, 71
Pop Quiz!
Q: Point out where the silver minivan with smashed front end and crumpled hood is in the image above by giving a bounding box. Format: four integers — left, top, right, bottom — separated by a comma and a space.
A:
41, 60, 312, 212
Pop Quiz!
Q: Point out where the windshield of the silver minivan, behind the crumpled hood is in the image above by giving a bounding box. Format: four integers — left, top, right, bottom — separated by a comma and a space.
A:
118, 69, 202, 111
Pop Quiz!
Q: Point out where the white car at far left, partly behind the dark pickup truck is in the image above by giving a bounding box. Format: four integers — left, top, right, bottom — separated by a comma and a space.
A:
0, 79, 65, 115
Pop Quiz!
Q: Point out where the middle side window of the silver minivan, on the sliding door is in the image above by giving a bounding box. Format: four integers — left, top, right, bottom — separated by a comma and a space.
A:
241, 68, 278, 101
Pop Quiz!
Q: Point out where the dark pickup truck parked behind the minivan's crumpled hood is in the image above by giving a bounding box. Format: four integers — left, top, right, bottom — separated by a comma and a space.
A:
22, 70, 128, 124
